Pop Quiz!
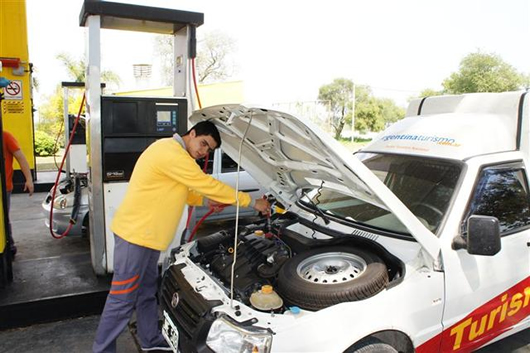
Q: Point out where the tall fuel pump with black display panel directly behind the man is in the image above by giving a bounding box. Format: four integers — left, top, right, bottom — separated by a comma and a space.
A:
80, 0, 204, 275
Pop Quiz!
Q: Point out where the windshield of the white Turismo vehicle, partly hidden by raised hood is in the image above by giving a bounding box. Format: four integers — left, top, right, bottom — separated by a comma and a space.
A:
300, 153, 462, 234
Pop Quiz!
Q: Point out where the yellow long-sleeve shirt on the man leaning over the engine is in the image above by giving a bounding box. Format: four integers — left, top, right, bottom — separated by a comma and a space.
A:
111, 138, 252, 251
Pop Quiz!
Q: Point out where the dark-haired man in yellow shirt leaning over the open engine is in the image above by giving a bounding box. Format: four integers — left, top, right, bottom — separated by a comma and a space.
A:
93, 121, 270, 352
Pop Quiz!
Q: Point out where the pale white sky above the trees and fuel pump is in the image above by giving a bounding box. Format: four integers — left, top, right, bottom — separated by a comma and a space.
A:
26, 0, 530, 108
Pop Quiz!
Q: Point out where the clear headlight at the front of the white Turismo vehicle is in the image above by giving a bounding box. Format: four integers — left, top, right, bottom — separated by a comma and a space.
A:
206, 317, 272, 353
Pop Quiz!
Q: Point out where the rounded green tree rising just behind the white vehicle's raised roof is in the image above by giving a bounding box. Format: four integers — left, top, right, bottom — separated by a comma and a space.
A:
442, 51, 527, 94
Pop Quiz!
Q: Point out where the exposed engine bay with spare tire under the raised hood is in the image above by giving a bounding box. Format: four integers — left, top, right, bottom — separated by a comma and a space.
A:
184, 213, 403, 312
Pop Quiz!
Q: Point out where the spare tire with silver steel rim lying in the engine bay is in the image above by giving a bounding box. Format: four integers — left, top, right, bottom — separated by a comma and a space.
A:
278, 246, 388, 310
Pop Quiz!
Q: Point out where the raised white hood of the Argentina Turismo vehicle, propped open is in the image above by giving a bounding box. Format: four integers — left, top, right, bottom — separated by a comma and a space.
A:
190, 105, 440, 259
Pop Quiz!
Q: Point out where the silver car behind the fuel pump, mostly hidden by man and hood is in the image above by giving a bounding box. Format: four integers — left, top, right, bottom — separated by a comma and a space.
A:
42, 149, 265, 236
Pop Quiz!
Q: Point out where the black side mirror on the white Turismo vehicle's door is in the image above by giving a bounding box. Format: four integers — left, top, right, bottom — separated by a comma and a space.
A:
466, 215, 501, 256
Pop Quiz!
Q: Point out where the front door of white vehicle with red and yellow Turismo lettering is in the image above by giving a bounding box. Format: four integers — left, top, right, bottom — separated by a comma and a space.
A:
441, 161, 530, 352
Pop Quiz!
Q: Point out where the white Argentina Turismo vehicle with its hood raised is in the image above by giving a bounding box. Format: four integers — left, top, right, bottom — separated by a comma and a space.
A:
161, 92, 530, 353
